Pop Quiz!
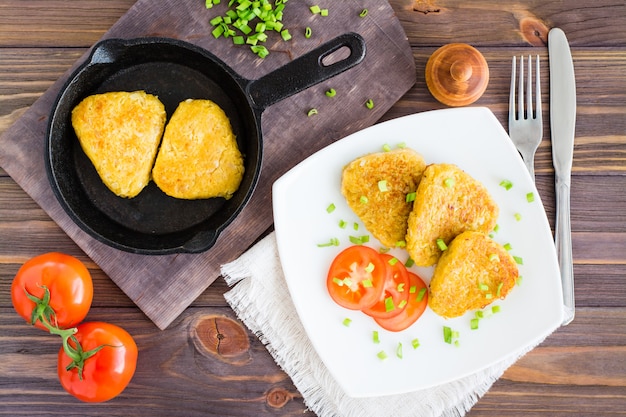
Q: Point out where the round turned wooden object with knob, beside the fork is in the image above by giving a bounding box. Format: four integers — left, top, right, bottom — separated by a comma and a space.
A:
426, 43, 489, 107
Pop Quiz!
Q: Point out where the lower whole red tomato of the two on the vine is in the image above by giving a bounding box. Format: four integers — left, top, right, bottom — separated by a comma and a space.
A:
57, 322, 138, 402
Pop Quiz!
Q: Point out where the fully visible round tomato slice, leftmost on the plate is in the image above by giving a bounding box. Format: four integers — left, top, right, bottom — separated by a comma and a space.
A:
326, 245, 387, 310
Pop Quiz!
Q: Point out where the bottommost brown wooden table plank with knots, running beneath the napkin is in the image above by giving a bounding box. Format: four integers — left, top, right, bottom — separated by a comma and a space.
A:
0, 307, 626, 417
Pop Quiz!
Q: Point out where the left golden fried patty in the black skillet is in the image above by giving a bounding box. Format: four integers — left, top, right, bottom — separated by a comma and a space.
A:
72, 91, 166, 198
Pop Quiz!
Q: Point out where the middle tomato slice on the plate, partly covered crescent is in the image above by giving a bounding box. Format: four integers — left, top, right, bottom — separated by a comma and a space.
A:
362, 253, 409, 318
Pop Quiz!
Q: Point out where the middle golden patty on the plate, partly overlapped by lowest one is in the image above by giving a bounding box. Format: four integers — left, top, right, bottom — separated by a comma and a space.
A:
406, 164, 499, 266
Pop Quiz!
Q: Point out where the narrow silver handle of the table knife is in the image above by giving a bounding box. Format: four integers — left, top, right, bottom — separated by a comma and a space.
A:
554, 176, 574, 326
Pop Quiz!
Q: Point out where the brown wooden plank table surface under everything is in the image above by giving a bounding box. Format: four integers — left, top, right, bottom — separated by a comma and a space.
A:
0, 0, 626, 417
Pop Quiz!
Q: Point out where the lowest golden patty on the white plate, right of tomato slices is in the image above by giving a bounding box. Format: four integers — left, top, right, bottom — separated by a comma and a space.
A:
428, 231, 519, 318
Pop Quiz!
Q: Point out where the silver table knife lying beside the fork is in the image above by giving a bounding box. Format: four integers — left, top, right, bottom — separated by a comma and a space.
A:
548, 28, 576, 325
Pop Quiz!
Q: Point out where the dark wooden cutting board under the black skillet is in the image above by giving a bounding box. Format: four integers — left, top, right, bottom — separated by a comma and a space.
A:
0, 0, 416, 329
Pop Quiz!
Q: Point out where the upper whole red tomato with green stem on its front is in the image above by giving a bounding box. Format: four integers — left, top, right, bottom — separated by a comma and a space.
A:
11, 252, 93, 330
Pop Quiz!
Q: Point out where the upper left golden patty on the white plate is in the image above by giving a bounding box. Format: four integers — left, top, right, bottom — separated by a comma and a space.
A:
341, 148, 426, 247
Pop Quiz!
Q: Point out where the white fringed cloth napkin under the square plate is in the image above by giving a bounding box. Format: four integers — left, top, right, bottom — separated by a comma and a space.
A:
221, 233, 541, 417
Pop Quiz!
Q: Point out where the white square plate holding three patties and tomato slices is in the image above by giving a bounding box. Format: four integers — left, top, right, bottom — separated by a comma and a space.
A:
273, 107, 562, 397
